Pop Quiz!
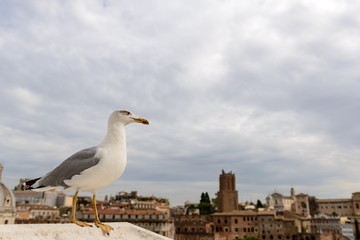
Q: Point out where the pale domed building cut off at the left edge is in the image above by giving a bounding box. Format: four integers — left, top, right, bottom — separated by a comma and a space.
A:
0, 164, 16, 224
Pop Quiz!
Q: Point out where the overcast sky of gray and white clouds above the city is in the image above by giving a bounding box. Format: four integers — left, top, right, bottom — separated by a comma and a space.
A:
0, 0, 360, 205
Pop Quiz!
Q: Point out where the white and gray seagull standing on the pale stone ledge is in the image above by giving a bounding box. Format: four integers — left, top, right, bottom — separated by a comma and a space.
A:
24, 110, 149, 235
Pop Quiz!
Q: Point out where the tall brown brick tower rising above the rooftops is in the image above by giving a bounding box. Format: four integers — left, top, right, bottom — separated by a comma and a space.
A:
217, 170, 238, 212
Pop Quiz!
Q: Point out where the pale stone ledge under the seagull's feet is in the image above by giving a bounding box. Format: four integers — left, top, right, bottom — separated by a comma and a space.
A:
0, 222, 170, 240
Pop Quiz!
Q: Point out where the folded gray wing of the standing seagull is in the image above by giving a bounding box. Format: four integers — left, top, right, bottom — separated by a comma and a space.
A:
37, 147, 100, 188
